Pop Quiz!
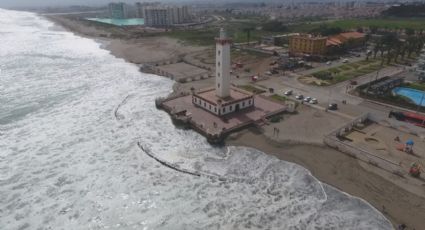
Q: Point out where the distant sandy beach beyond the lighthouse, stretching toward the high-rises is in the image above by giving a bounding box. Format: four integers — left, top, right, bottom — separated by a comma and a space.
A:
47, 16, 205, 64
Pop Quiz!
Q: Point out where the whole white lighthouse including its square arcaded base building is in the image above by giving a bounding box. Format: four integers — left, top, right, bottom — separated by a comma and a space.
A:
192, 28, 254, 116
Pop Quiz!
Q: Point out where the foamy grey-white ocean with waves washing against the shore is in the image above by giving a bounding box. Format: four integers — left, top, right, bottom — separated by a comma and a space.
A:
0, 9, 392, 229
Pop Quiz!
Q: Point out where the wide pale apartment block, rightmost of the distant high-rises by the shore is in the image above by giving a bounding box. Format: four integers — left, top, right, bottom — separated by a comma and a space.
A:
143, 6, 190, 27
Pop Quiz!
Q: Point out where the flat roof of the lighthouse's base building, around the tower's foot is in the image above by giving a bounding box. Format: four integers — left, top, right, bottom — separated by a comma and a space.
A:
194, 87, 253, 106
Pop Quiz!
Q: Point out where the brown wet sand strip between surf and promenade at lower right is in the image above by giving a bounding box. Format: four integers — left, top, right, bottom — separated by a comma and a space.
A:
226, 128, 425, 229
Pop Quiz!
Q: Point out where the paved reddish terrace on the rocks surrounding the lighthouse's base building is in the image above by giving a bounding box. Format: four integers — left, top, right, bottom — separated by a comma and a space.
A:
159, 95, 286, 142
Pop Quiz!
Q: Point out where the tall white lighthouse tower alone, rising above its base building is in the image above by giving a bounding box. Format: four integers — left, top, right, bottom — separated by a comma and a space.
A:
215, 28, 232, 98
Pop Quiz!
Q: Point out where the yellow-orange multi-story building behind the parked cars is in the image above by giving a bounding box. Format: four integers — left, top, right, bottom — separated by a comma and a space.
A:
289, 34, 327, 56
